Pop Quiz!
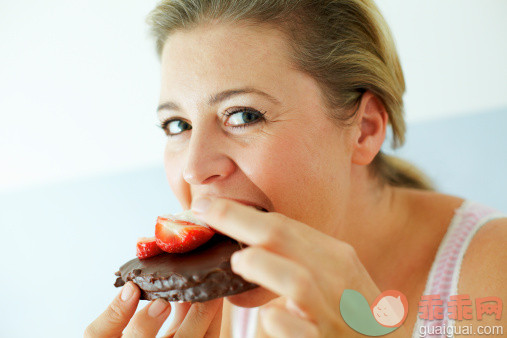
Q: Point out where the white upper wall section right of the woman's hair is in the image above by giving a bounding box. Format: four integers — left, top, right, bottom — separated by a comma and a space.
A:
377, 0, 507, 122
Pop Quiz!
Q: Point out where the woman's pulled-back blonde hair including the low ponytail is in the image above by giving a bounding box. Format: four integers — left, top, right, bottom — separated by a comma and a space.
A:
147, 0, 434, 190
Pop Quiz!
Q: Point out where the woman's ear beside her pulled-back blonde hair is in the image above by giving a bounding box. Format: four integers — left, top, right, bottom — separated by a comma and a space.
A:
352, 91, 389, 165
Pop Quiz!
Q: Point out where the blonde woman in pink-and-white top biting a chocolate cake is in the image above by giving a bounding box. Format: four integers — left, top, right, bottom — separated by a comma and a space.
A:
85, 0, 507, 337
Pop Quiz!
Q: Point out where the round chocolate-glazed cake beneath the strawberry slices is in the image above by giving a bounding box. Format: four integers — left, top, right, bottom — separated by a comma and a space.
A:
114, 234, 258, 302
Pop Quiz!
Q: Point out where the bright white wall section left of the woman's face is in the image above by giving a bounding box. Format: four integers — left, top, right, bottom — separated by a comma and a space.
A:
0, 0, 164, 189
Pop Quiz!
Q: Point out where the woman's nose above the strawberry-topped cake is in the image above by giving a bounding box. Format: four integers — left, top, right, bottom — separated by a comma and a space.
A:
183, 129, 236, 185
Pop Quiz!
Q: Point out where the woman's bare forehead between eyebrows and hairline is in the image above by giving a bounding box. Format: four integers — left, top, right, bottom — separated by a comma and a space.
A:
162, 24, 290, 86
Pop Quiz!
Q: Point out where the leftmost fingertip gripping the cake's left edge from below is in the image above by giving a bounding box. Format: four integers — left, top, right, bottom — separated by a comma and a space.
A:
84, 282, 141, 338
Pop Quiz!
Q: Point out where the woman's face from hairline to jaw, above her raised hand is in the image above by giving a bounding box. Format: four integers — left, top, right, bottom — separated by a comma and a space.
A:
159, 23, 351, 238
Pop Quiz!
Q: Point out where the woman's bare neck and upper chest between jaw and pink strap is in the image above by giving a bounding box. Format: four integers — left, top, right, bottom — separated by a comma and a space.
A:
342, 167, 463, 289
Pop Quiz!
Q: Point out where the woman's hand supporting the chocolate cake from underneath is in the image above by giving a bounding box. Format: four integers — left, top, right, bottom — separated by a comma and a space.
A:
84, 282, 223, 337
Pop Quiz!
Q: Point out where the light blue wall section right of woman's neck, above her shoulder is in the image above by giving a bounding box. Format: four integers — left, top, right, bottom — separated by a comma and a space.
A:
384, 108, 507, 212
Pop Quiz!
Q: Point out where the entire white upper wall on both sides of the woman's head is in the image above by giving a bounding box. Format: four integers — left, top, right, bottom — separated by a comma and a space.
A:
0, 0, 507, 191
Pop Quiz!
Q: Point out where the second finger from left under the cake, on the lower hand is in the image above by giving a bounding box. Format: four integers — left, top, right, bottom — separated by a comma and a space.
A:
124, 298, 171, 338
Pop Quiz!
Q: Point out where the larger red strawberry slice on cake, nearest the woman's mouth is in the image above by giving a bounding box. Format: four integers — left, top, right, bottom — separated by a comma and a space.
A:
155, 211, 215, 253
